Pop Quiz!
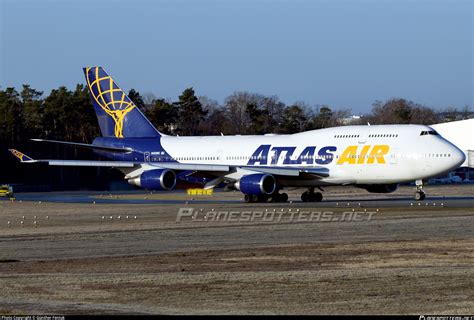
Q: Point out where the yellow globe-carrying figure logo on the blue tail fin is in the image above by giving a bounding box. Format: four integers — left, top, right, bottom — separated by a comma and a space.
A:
86, 67, 135, 138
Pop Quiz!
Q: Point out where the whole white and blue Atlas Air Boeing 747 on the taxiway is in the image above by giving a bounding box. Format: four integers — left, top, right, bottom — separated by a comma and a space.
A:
10, 67, 465, 202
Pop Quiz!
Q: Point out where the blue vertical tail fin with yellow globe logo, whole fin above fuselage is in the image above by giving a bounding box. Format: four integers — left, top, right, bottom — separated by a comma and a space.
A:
84, 67, 161, 138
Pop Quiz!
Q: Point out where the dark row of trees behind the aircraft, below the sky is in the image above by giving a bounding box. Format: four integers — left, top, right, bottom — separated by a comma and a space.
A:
0, 84, 472, 191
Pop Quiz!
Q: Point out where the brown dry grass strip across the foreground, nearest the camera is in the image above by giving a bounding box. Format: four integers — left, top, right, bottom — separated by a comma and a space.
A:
0, 240, 474, 314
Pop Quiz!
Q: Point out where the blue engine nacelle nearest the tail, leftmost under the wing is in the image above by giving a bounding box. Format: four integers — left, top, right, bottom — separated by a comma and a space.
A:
128, 169, 176, 190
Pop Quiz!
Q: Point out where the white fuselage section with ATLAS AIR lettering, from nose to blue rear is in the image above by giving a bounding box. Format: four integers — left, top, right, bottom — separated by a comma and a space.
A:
157, 125, 464, 186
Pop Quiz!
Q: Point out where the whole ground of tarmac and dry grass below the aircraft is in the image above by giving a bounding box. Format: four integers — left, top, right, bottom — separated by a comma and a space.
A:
0, 185, 474, 314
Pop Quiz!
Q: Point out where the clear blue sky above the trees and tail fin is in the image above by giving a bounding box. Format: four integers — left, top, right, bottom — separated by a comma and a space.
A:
0, 0, 474, 114
